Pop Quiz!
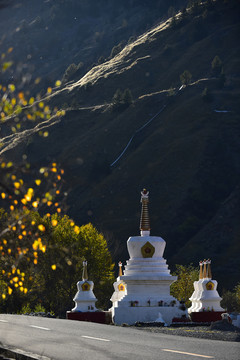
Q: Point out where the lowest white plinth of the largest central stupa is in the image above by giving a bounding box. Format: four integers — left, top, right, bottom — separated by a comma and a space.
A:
111, 306, 188, 325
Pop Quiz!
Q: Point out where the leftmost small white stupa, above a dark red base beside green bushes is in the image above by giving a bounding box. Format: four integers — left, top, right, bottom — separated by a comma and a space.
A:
72, 261, 97, 312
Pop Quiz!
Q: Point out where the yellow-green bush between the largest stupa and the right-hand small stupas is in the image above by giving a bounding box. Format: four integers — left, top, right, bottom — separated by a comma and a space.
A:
170, 264, 199, 307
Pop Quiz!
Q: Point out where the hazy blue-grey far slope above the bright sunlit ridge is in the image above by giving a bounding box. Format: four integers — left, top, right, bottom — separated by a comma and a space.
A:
0, 0, 186, 92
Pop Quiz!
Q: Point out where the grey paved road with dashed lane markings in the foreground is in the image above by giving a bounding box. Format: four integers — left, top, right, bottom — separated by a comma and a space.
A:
0, 314, 240, 360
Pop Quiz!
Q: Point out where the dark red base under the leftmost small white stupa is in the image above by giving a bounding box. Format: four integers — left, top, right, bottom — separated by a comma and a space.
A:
66, 311, 112, 324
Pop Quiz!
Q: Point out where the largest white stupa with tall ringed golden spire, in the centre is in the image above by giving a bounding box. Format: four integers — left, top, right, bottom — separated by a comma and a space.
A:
111, 189, 186, 325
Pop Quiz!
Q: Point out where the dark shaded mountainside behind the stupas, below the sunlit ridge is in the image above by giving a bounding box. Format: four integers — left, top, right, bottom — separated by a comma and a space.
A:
1, 0, 240, 286
